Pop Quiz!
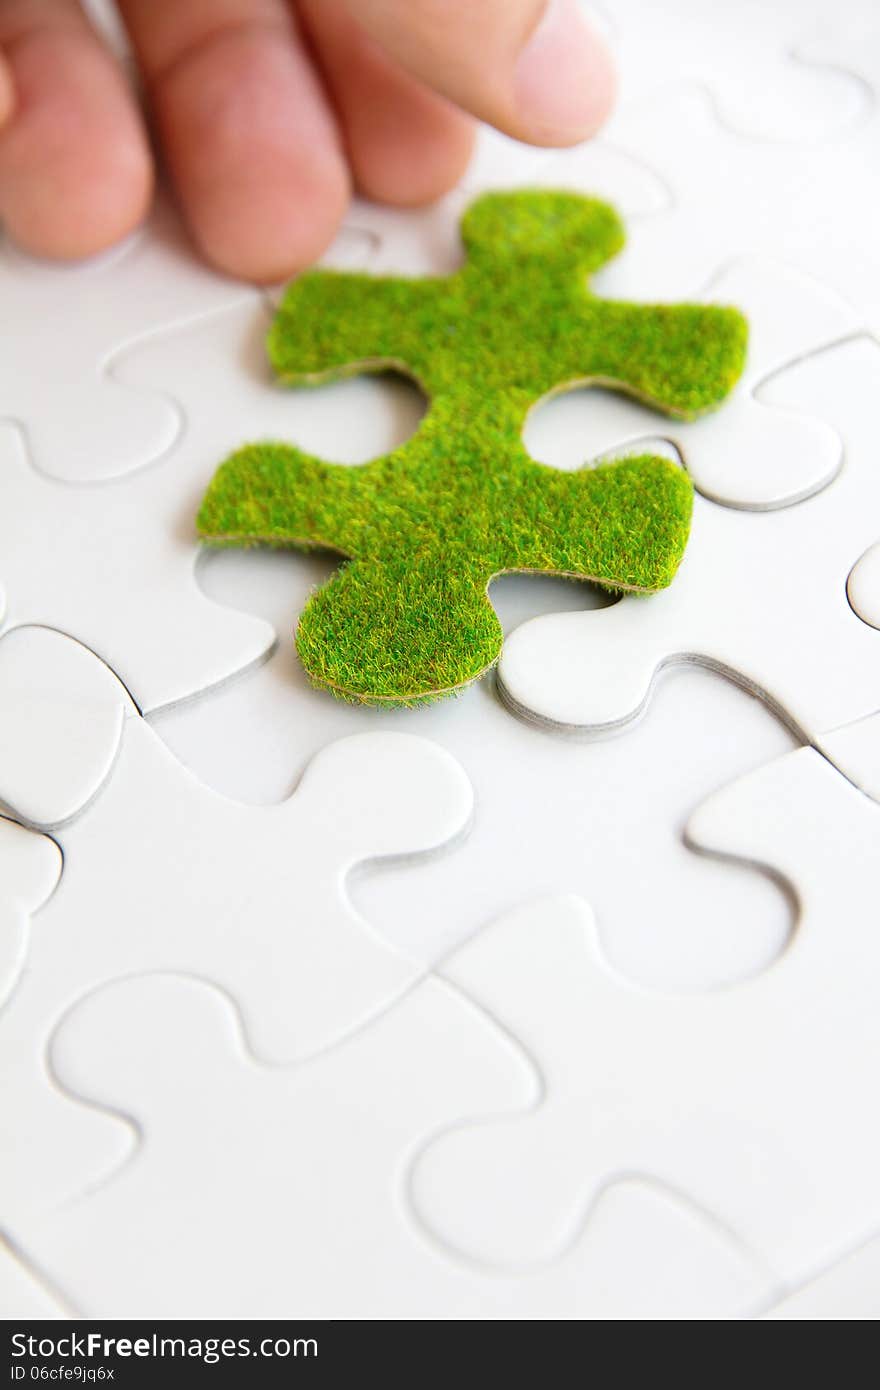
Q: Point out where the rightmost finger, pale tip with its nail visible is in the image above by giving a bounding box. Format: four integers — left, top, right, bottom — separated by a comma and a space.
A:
339, 0, 614, 145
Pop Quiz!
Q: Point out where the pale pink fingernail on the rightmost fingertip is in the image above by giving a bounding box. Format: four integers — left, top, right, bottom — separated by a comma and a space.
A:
514, 0, 614, 145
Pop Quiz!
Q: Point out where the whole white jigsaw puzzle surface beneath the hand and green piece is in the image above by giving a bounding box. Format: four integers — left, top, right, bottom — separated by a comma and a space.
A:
0, 0, 880, 1321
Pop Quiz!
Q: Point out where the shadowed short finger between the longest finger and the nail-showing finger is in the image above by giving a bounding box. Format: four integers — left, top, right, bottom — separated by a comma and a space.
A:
299, 0, 474, 206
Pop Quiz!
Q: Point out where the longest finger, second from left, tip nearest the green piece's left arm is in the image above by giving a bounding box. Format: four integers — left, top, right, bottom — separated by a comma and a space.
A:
120, 0, 349, 282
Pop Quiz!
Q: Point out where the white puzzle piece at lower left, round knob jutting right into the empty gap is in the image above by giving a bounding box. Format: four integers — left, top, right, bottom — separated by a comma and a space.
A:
0, 631, 471, 1209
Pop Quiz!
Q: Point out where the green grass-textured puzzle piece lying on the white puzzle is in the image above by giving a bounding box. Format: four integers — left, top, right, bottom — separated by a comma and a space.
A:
197, 192, 747, 705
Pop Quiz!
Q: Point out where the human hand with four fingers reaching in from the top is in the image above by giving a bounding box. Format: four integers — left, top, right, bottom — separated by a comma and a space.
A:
0, 0, 613, 281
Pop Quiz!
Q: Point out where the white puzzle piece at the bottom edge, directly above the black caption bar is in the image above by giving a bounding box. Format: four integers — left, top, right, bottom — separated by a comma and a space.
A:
17, 976, 770, 1319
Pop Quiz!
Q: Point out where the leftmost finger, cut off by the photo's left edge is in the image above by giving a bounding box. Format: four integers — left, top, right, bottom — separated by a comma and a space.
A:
0, 0, 153, 257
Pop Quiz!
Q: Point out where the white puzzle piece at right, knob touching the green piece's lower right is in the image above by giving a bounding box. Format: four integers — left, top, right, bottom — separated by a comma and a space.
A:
499, 339, 880, 741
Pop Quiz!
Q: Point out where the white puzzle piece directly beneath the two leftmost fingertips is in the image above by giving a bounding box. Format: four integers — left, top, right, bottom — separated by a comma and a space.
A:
0, 200, 257, 482
